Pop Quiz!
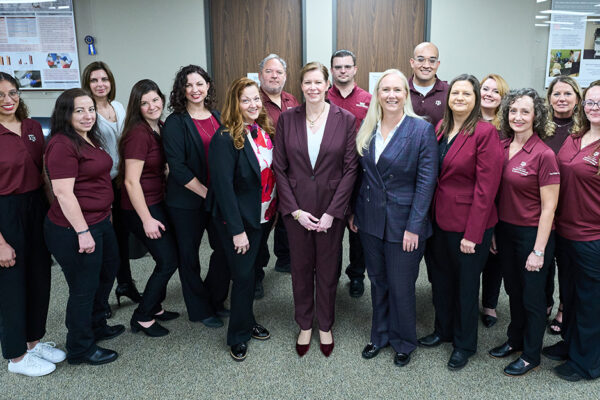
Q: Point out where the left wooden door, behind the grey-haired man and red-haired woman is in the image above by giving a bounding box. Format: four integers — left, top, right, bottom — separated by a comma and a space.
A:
209, 0, 302, 108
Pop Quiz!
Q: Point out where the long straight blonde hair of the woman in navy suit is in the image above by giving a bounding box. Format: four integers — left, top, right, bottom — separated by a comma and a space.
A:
356, 69, 422, 156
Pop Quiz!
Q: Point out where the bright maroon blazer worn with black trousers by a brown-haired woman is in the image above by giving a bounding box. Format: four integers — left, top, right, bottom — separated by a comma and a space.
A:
433, 121, 504, 243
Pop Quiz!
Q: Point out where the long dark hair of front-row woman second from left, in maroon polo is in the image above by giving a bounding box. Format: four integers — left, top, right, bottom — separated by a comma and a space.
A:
50, 88, 104, 152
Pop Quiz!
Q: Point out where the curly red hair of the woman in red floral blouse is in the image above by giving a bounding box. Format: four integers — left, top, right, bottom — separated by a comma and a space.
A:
221, 77, 275, 150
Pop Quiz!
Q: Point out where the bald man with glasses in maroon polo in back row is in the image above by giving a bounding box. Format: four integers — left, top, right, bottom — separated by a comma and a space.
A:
408, 42, 449, 126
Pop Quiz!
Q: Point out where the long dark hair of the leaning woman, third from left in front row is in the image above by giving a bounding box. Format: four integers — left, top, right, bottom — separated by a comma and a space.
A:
117, 79, 165, 185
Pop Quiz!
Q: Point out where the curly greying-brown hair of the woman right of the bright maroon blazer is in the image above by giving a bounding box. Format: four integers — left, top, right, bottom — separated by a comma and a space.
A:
500, 88, 554, 139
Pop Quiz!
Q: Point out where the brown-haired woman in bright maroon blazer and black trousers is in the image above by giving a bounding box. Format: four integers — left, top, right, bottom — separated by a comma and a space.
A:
419, 74, 503, 370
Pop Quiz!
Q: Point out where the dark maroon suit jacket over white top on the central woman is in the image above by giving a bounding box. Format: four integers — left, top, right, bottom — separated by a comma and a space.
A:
273, 104, 358, 219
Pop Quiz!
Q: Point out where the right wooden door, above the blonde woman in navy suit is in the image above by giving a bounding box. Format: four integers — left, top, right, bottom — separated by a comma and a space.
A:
337, 0, 425, 90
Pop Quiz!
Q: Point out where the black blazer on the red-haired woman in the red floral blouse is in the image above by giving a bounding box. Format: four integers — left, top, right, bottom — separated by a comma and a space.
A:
206, 126, 262, 237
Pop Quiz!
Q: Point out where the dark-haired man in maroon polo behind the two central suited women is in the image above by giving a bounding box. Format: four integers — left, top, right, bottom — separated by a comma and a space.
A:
327, 50, 371, 297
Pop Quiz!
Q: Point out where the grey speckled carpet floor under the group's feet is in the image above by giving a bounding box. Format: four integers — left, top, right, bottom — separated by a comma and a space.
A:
0, 233, 600, 400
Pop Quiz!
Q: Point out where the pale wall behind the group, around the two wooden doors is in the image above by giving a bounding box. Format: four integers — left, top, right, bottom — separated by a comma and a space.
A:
24, 0, 550, 116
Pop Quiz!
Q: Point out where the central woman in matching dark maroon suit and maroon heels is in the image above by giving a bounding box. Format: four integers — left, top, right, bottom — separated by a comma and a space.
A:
274, 62, 358, 357
